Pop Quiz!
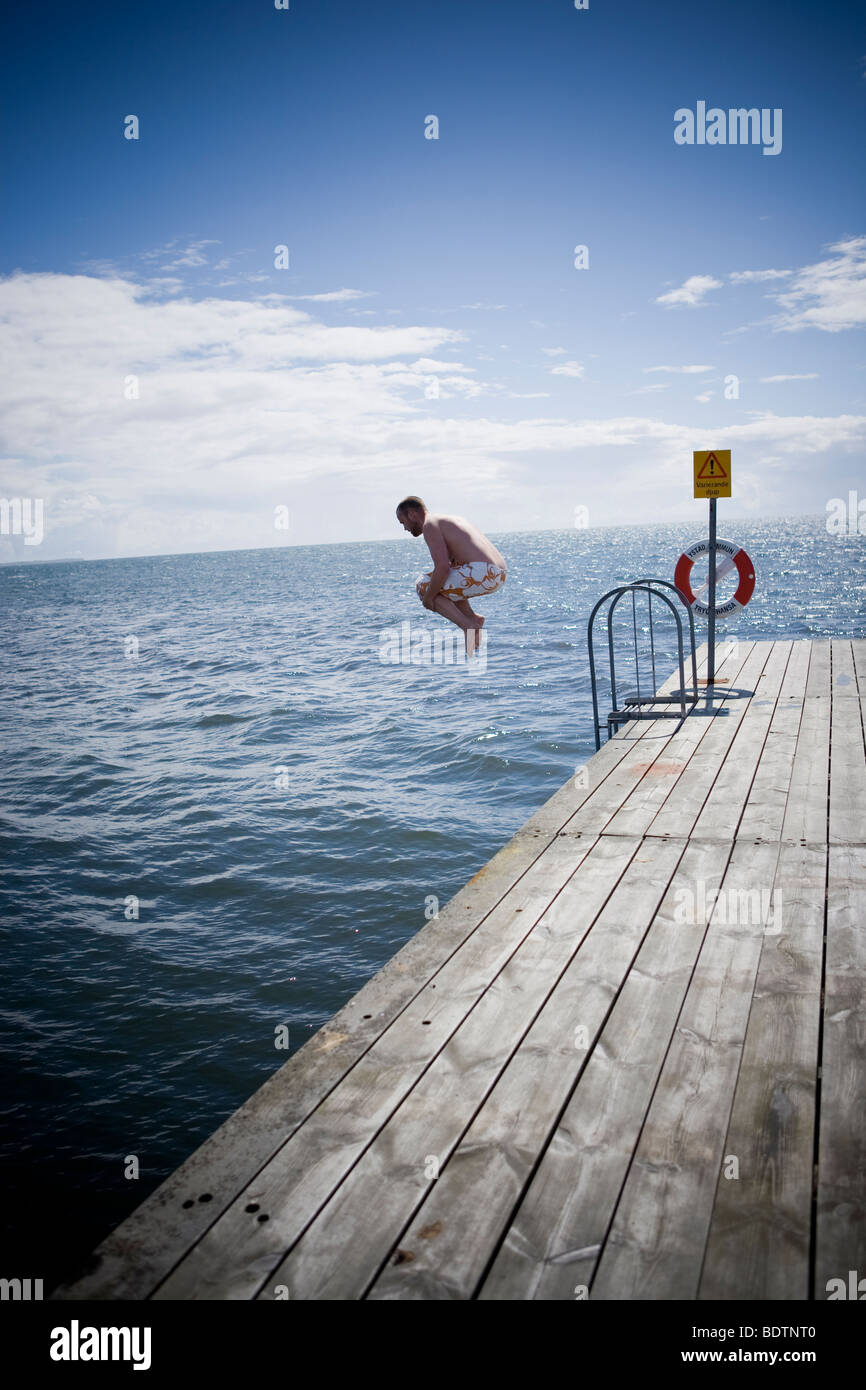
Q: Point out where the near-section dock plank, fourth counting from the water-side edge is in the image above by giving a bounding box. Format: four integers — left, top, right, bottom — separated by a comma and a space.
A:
370, 840, 684, 1298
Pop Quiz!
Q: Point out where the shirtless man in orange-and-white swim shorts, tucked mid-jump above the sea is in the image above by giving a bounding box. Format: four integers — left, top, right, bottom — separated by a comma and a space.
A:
398, 498, 506, 656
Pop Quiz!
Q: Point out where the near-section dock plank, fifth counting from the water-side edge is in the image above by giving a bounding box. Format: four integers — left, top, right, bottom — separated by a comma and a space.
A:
478, 841, 733, 1300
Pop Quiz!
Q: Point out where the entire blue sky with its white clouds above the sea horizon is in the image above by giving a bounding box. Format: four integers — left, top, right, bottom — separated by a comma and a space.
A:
0, 0, 866, 560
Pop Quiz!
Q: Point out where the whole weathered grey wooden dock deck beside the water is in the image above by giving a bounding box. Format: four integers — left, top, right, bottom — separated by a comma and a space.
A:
53, 641, 866, 1300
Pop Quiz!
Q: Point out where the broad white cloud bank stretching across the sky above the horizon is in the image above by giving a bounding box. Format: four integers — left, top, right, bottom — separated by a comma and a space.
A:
0, 274, 866, 560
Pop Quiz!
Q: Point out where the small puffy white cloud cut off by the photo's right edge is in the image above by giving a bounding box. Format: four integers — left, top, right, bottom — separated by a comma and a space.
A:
774, 236, 866, 334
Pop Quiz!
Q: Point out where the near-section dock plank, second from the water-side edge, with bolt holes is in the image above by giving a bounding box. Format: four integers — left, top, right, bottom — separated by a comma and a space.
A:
154, 835, 635, 1298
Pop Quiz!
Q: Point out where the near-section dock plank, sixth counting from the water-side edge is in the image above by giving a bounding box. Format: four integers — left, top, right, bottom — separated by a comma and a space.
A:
591, 841, 778, 1300
